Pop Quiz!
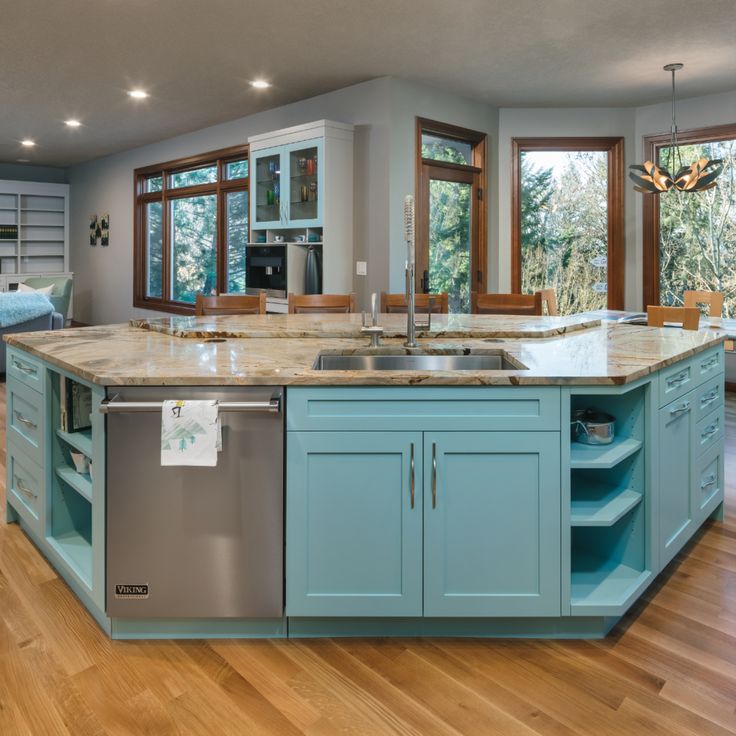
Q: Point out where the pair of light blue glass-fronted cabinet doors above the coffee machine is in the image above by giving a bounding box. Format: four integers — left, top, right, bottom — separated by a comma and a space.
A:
250, 138, 324, 229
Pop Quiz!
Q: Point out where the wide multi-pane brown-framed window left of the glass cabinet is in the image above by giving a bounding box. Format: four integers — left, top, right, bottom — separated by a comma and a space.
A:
133, 146, 248, 314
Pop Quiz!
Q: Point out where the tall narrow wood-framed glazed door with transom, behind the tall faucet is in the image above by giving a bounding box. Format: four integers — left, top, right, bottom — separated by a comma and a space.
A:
416, 118, 486, 313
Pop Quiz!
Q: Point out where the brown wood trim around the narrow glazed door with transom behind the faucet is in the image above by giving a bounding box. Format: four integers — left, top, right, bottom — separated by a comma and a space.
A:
414, 117, 488, 292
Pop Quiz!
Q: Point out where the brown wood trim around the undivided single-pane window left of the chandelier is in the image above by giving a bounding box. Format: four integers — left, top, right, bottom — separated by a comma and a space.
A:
511, 136, 626, 309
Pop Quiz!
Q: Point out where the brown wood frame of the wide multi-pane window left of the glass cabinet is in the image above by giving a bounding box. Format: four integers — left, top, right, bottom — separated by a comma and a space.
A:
133, 145, 250, 314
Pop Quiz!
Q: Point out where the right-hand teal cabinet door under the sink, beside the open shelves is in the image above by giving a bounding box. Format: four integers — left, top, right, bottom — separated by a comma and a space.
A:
424, 432, 560, 616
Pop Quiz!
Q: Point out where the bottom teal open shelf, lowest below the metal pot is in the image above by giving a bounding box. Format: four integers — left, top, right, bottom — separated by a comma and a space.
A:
571, 553, 651, 613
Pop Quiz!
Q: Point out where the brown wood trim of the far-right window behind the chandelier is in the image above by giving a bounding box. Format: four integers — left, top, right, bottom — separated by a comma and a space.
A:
641, 123, 736, 308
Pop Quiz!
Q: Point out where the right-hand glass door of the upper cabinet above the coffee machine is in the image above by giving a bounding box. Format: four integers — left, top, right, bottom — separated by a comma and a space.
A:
289, 141, 323, 226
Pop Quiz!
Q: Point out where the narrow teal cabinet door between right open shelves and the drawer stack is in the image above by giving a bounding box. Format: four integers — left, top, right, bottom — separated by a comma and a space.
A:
659, 392, 695, 569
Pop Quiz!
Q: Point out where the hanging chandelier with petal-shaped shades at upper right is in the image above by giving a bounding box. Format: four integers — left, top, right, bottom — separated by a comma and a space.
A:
629, 64, 723, 194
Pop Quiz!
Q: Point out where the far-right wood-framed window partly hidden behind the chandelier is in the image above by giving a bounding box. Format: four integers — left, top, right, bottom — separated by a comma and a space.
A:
642, 125, 736, 318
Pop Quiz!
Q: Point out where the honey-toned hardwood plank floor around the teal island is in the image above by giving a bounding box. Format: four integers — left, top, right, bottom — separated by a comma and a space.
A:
0, 385, 736, 736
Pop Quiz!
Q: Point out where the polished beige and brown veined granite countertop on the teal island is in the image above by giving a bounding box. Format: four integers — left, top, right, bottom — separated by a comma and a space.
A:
4, 315, 725, 386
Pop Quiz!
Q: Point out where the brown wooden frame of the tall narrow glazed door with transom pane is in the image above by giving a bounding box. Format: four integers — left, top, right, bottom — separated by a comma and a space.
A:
415, 117, 488, 299
